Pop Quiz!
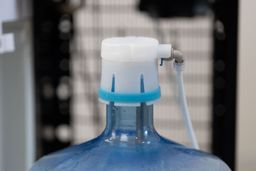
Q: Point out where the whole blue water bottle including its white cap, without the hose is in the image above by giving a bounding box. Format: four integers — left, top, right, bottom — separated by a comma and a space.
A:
31, 37, 230, 171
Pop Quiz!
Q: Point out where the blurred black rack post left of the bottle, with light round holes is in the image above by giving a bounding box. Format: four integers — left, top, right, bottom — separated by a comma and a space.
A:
33, 0, 73, 157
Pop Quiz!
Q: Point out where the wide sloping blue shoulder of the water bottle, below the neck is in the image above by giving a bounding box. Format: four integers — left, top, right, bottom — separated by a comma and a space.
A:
31, 138, 230, 171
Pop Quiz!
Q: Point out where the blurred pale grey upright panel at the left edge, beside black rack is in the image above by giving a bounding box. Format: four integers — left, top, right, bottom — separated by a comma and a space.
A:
0, 20, 35, 171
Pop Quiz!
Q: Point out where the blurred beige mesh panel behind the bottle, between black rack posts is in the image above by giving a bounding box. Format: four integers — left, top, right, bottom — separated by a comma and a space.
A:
72, 0, 212, 151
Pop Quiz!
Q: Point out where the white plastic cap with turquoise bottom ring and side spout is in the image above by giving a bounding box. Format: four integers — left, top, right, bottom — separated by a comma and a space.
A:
99, 37, 171, 106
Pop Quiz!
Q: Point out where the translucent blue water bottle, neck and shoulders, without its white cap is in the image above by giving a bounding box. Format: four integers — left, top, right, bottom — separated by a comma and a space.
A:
30, 103, 230, 171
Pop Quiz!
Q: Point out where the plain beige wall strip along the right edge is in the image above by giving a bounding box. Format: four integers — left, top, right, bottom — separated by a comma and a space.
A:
237, 0, 256, 171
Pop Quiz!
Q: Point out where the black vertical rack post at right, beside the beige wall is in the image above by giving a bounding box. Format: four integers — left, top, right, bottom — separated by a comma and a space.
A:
212, 0, 238, 170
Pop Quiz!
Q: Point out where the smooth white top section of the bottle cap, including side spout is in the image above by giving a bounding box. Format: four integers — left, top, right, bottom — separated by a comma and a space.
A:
101, 36, 171, 62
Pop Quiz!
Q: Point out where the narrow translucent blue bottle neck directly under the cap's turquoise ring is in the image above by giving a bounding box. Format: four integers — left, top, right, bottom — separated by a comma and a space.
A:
104, 103, 159, 144
